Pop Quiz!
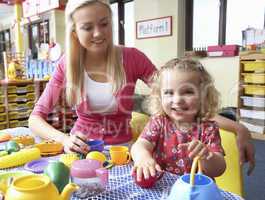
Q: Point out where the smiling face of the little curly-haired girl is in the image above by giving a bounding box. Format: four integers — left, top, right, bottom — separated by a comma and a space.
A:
161, 70, 200, 123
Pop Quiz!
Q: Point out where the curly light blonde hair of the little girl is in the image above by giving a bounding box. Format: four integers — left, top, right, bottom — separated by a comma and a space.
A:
145, 57, 219, 120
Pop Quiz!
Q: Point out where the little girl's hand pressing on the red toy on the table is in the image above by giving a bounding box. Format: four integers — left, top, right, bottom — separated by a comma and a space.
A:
132, 158, 163, 181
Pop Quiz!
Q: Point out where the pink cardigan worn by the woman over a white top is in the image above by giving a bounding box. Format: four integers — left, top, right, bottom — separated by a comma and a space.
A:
31, 47, 156, 144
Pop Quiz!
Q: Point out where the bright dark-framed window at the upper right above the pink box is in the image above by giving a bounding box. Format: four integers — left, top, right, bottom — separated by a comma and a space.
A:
185, 0, 265, 50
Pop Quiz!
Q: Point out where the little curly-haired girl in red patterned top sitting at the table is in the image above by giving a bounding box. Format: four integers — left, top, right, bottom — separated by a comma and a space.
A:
131, 58, 226, 181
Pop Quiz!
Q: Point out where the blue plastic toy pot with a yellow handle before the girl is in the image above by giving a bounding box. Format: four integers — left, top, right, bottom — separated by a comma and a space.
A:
168, 157, 223, 200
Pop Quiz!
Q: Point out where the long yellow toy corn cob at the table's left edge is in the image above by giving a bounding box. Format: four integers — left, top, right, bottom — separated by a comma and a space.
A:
0, 148, 40, 169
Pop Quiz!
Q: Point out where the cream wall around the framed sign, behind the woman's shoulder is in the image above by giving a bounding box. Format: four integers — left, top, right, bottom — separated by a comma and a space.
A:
134, 0, 185, 94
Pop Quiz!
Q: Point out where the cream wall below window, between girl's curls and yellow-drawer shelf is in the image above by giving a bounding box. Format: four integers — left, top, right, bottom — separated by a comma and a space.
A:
200, 56, 240, 107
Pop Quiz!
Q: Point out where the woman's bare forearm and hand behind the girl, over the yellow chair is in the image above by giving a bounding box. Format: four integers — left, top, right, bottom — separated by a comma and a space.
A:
213, 115, 255, 175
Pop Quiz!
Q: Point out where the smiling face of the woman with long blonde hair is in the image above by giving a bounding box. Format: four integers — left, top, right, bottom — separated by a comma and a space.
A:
73, 3, 112, 54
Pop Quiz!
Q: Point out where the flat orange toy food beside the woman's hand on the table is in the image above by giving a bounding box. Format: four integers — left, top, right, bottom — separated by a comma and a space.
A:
35, 140, 63, 156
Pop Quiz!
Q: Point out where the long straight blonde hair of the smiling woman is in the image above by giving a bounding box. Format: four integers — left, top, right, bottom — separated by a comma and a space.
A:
65, 0, 126, 105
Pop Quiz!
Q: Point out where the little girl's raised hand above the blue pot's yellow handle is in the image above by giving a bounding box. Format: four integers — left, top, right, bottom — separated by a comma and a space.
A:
178, 139, 213, 160
